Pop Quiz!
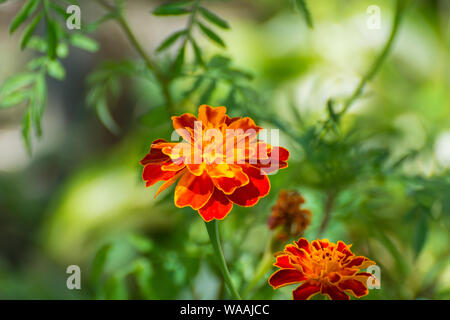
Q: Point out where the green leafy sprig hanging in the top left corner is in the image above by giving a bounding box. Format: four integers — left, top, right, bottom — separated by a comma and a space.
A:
0, 0, 98, 154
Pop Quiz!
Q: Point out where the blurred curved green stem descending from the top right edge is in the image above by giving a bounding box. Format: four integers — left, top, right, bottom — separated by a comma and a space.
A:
339, 0, 406, 116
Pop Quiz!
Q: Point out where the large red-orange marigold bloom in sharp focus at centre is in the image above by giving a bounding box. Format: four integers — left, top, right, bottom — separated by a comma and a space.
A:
141, 105, 289, 221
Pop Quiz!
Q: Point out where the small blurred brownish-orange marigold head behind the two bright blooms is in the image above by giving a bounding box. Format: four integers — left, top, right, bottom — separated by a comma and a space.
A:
267, 190, 311, 240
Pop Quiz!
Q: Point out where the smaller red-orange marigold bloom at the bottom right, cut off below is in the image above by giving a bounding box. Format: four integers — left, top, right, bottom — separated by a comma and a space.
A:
269, 238, 375, 300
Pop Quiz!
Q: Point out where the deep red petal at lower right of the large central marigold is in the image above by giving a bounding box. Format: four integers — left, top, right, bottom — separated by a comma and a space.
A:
228, 166, 270, 207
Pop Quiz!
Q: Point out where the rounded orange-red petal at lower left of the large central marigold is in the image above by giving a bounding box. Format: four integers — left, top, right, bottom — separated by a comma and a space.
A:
174, 171, 214, 210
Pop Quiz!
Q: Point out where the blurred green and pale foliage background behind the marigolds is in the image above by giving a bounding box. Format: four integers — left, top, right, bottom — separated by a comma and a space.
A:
0, 0, 450, 299
